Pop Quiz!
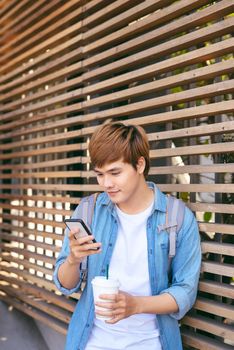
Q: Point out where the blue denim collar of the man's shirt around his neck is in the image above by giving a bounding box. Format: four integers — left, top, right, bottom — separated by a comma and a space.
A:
100, 182, 167, 213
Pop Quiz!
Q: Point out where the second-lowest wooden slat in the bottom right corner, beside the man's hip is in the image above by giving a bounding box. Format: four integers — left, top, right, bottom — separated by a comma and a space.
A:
182, 316, 234, 341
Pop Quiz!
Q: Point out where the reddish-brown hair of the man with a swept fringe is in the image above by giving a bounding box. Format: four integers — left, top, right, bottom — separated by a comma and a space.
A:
89, 122, 149, 176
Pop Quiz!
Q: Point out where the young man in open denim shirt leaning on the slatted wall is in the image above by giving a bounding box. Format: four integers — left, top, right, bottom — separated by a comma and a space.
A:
54, 123, 201, 350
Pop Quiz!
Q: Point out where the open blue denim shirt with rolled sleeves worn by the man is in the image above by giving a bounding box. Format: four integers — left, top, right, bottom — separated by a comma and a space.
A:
54, 183, 201, 350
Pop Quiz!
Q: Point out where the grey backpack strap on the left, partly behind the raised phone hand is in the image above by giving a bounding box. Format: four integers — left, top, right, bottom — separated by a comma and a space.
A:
80, 193, 98, 281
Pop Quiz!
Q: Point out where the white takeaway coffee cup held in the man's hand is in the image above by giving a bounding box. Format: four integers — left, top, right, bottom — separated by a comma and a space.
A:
91, 276, 119, 321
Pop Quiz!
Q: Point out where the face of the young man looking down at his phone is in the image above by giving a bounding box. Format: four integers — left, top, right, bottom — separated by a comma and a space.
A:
94, 160, 144, 208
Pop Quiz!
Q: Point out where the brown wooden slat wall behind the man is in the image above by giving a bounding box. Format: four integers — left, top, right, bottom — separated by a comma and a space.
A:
0, 0, 234, 350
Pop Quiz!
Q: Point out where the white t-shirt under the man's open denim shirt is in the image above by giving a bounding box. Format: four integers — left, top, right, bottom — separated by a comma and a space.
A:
85, 203, 162, 350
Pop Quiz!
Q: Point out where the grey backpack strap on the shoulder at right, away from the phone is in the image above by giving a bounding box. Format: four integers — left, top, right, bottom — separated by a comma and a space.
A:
167, 196, 185, 272
